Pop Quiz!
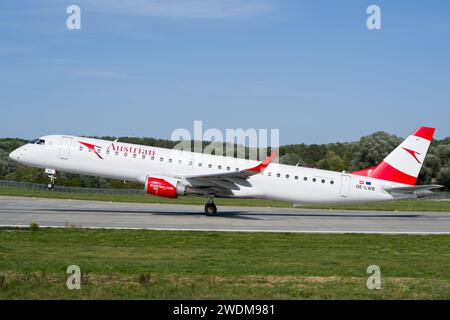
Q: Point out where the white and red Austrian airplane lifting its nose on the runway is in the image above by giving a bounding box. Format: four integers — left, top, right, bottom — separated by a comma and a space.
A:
9, 127, 441, 216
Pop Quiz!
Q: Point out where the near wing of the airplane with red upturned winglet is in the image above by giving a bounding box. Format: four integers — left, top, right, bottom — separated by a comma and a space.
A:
180, 152, 277, 197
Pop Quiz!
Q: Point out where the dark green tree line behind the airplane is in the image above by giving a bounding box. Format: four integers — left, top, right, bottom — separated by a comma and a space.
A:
0, 132, 450, 190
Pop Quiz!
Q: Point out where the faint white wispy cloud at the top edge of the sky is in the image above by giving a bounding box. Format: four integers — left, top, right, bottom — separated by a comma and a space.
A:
79, 0, 273, 19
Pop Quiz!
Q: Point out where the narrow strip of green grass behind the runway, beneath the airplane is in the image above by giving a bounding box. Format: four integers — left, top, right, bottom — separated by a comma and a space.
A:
0, 187, 450, 212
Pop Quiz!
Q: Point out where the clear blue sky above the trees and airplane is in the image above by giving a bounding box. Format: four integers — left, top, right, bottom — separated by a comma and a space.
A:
0, 0, 450, 144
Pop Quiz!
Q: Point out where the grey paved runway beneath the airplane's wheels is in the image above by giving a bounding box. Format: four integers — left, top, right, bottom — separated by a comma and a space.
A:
0, 197, 450, 234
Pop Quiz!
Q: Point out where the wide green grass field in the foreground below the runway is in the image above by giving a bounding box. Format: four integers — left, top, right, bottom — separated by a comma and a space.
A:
0, 228, 450, 299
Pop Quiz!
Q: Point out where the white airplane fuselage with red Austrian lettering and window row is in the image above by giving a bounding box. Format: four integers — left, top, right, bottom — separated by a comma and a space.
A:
10, 135, 402, 204
